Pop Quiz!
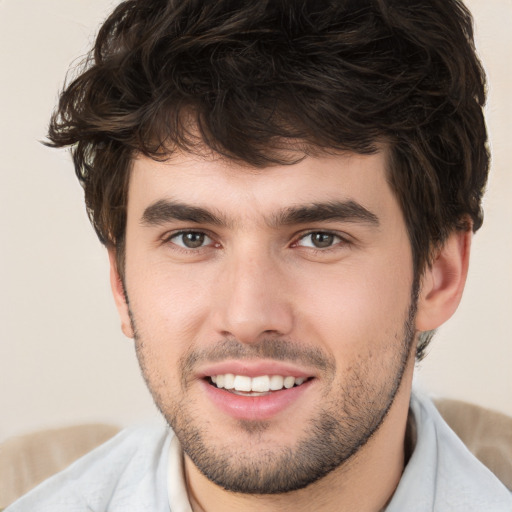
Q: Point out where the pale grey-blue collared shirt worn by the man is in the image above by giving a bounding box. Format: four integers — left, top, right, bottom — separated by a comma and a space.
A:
5, 392, 512, 512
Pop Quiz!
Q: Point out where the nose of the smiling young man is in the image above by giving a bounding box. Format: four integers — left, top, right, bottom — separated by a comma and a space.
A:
213, 251, 294, 344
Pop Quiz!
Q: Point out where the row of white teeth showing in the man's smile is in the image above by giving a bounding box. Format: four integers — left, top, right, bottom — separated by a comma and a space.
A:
208, 373, 311, 396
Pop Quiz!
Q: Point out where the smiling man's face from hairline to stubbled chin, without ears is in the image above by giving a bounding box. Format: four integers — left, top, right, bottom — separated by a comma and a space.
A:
121, 153, 415, 493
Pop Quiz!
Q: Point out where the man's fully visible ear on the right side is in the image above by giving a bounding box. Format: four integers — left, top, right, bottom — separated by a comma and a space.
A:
416, 230, 472, 331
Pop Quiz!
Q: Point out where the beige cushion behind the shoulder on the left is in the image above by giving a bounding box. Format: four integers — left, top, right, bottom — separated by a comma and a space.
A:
0, 424, 120, 509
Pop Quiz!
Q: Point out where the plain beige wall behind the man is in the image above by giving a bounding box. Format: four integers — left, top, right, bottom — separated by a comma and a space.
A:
0, 0, 512, 439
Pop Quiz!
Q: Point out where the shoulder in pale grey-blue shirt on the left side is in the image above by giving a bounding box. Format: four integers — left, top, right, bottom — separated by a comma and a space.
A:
5, 427, 172, 512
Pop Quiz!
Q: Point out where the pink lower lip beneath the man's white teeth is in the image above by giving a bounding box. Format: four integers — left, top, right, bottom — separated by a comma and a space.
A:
202, 380, 313, 421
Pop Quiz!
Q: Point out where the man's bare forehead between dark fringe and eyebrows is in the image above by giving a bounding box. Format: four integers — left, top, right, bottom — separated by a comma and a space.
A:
128, 150, 397, 219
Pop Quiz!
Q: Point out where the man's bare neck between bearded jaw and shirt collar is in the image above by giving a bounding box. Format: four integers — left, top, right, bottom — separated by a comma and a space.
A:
185, 367, 413, 512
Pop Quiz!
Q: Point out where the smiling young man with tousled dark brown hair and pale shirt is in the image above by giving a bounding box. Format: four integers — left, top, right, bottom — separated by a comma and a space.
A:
9, 0, 512, 512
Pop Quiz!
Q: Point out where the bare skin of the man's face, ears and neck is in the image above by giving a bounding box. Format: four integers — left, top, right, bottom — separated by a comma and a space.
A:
110, 146, 470, 512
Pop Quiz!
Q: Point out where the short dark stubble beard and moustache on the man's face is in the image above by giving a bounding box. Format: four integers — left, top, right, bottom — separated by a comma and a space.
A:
132, 296, 417, 494
